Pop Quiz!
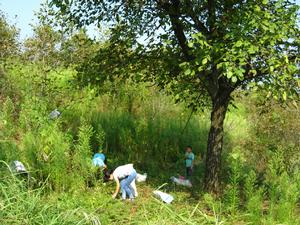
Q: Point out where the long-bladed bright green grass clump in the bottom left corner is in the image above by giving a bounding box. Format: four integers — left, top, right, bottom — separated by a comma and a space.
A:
0, 166, 97, 225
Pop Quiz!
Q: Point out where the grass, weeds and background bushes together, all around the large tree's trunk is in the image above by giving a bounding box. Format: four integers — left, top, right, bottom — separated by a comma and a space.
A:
0, 1, 300, 224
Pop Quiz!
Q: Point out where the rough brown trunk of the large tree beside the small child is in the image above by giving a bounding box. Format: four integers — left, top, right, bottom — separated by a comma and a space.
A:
204, 92, 230, 194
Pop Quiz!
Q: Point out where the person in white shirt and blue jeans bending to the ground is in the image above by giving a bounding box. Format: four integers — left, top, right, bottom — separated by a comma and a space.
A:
104, 164, 137, 200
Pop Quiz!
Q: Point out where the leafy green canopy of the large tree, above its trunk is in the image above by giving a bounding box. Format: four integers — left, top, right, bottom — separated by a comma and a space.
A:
51, 0, 300, 105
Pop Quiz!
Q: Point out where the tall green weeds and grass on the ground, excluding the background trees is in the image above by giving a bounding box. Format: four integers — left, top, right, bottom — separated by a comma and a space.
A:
0, 55, 300, 224
